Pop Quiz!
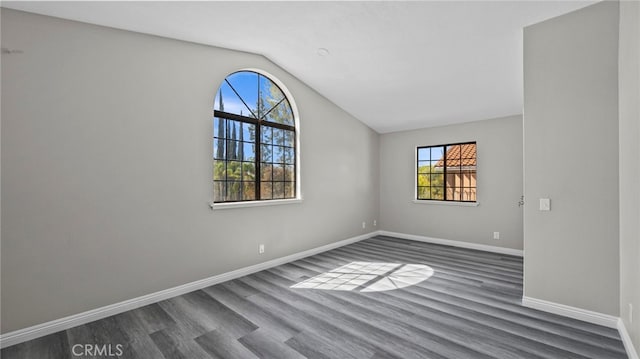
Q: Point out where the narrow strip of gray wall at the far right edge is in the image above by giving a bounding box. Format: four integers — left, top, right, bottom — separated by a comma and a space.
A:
618, 1, 640, 353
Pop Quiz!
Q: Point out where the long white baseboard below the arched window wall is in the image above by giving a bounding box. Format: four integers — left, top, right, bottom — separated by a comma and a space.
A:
0, 232, 378, 348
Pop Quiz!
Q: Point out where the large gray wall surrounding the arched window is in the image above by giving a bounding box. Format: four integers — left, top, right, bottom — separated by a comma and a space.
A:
1, 9, 379, 333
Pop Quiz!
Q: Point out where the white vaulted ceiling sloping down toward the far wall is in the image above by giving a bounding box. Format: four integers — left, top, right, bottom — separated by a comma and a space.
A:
2, 1, 594, 133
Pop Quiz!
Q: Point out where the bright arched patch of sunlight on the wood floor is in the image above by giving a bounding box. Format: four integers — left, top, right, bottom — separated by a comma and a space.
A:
291, 262, 434, 292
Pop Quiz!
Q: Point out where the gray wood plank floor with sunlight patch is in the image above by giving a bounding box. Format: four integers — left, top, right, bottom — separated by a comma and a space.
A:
1, 236, 627, 359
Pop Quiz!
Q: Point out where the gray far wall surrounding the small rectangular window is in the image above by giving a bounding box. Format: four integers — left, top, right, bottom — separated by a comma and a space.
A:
380, 115, 522, 249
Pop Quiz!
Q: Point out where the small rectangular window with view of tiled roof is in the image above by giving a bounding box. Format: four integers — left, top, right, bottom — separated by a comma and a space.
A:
416, 142, 477, 202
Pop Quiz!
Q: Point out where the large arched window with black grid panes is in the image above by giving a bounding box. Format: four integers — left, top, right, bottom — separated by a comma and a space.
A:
213, 71, 297, 203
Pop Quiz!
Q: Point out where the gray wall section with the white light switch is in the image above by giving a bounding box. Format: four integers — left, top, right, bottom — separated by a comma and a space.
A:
524, 1, 619, 316
